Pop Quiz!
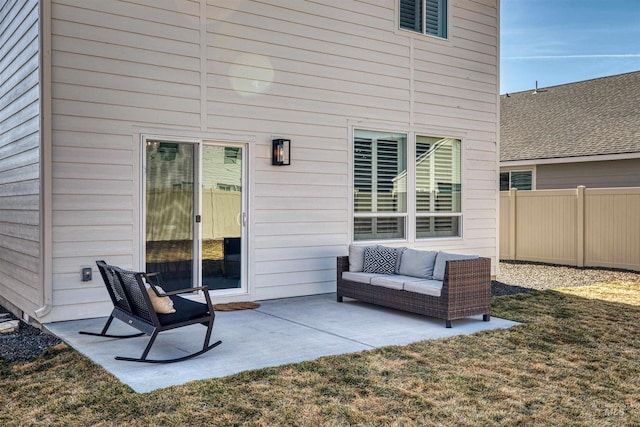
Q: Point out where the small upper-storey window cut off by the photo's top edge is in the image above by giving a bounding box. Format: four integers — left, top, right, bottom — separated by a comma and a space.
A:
400, 0, 447, 38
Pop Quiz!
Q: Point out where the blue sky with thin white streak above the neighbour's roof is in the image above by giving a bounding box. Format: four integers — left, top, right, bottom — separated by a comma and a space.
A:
500, 0, 640, 94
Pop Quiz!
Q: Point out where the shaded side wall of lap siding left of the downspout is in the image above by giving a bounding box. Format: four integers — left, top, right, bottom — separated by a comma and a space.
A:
0, 0, 43, 313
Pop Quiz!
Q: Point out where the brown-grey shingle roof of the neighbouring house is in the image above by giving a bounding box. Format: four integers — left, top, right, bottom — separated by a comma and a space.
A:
500, 71, 640, 161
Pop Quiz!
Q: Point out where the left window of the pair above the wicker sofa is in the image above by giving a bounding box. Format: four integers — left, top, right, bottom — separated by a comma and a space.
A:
353, 130, 407, 240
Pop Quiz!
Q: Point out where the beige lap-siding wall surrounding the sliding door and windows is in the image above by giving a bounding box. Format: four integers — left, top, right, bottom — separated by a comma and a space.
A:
38, 0, 499, 321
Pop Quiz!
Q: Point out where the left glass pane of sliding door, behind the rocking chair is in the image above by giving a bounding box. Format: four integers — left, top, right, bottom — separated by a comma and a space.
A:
145, 141, 196, 291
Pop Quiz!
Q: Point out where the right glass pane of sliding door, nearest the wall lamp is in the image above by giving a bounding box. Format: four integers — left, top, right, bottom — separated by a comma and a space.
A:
201, 145, 245, 290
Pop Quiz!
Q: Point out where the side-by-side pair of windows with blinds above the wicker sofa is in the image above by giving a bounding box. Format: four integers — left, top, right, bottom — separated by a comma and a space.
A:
353, 130, 462, 240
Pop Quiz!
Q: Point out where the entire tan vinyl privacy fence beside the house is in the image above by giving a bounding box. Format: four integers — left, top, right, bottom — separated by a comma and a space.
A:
500, 186, 640, 271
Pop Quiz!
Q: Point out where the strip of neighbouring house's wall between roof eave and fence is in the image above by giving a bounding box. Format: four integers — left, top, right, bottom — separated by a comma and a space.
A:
536, 159, 640, 190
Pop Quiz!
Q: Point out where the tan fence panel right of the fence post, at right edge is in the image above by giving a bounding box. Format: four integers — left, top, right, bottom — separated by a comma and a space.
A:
585, 188, 640, 270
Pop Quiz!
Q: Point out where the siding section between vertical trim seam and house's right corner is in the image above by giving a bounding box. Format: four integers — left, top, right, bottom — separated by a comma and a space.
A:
413, 1, 498, 273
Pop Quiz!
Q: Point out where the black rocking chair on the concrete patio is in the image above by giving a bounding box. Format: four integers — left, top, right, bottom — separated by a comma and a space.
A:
80, 261, 222, 363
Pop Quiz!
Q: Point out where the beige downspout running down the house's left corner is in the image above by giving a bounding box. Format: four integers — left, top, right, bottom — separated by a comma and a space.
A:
35, 0, 53, 319
